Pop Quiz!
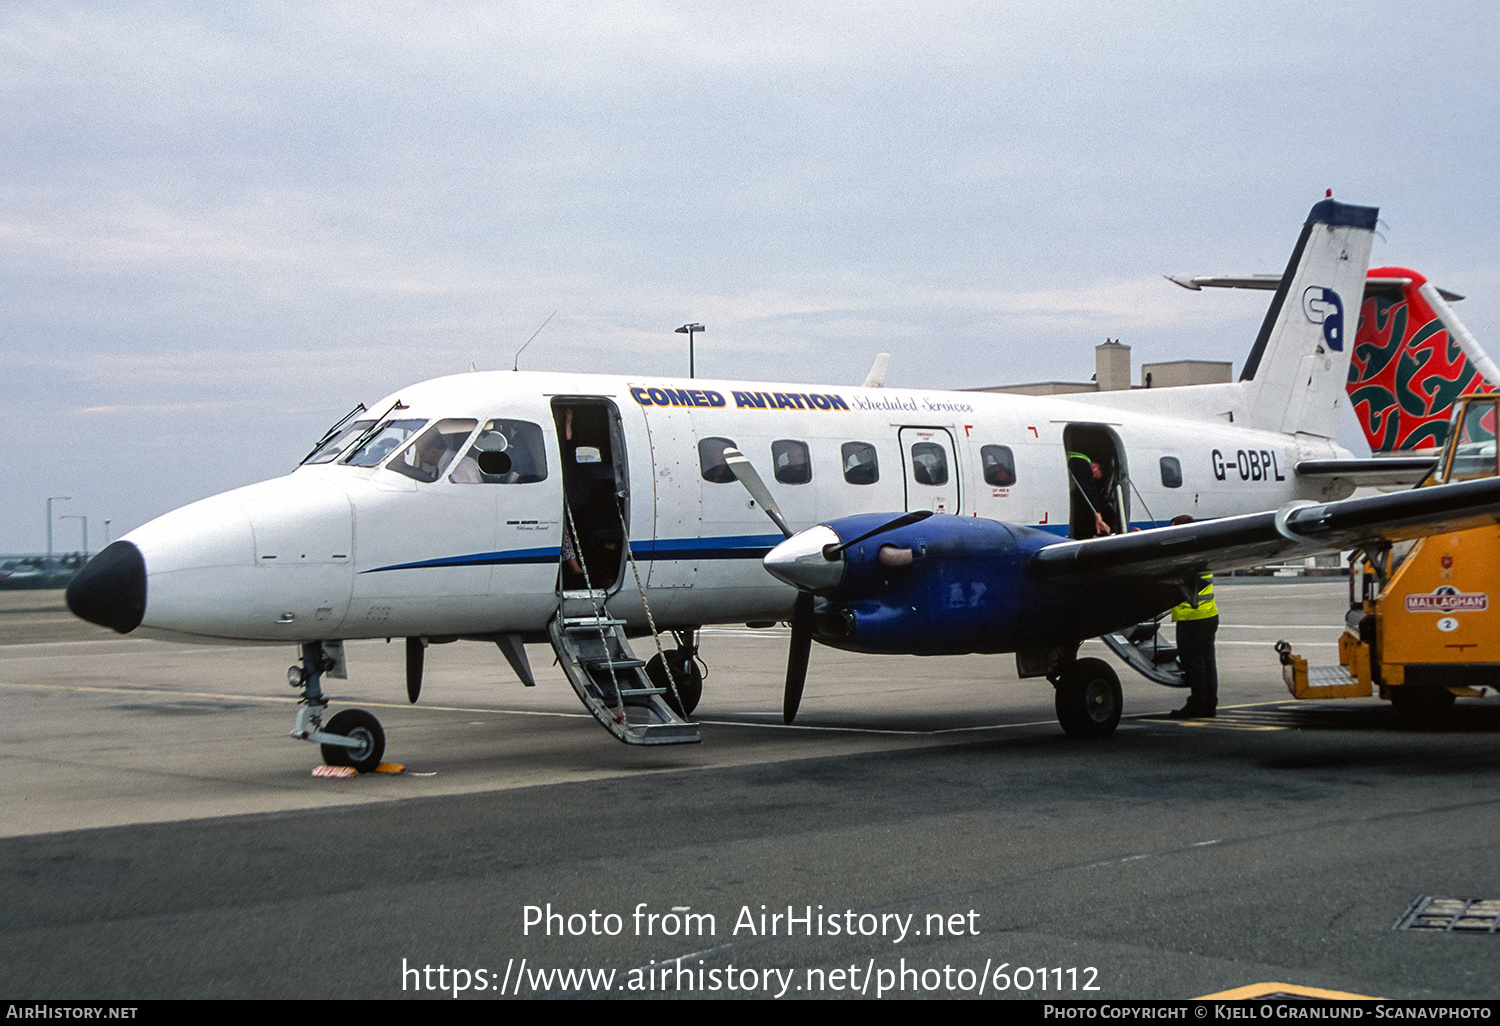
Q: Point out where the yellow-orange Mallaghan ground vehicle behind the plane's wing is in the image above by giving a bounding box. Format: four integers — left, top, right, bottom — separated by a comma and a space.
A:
1277, 395, 1500, 722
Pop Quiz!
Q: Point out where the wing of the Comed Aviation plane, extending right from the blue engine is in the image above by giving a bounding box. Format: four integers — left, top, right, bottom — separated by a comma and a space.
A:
1028, 477, 1500, 581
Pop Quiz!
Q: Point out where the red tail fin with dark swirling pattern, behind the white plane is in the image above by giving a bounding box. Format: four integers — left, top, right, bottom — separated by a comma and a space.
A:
1349, 267, 1500, 453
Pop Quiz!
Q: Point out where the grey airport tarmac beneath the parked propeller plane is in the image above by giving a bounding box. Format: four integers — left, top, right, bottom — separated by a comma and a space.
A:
0, 579, 1500, 1001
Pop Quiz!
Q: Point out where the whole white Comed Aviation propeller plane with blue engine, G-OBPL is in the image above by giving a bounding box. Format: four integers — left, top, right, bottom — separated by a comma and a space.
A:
68, 200, 1500, 770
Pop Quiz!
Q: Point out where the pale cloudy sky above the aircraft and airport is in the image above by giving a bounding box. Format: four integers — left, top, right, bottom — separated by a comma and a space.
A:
0, 0, 1500, 552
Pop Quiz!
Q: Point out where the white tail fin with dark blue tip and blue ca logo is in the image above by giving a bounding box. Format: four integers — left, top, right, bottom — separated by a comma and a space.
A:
1241, 200, 1380, 438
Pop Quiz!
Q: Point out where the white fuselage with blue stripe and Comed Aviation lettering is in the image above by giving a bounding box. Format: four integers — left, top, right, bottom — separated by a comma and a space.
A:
125, 372, 1344, 642
